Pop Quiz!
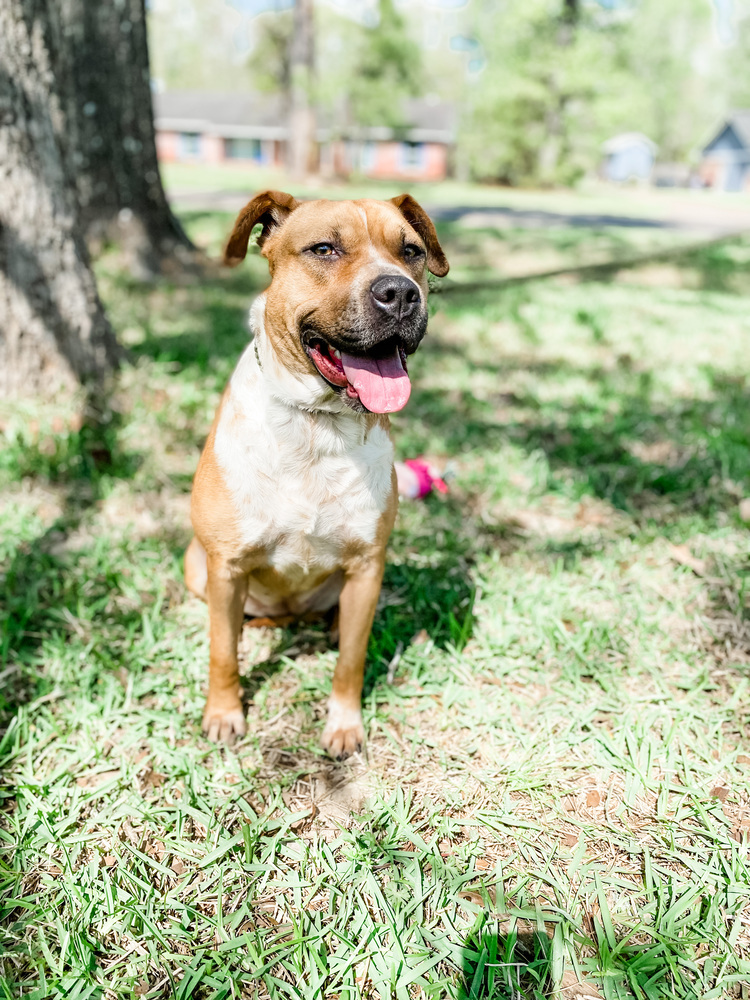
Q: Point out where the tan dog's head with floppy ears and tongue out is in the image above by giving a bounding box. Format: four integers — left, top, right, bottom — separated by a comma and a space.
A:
224, 191, 448, 413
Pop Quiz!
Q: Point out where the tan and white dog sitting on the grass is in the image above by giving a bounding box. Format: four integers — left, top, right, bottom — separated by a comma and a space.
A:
185, 191, 448, 759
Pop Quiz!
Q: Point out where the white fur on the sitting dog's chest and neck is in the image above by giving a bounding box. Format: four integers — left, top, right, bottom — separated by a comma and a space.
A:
214, 296, 393, 586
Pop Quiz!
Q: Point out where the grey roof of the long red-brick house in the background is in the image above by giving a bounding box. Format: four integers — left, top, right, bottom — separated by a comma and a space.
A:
153, 90, 457, 143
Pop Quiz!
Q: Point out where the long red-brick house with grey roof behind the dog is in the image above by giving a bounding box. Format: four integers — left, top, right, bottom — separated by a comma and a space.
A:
154, 91, 456, 181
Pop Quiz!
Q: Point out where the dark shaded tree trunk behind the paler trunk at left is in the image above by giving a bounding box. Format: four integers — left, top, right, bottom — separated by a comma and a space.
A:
55, 0, 195, 276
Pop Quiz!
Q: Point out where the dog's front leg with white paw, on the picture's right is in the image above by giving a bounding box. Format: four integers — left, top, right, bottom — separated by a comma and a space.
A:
322, 554, 385, 760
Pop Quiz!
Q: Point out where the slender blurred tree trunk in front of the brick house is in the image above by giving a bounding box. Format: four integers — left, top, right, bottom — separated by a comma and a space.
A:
289, 0, 315, 180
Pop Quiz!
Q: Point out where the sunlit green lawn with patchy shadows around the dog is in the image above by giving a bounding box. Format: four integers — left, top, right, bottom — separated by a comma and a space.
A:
0, 199, 750, 1000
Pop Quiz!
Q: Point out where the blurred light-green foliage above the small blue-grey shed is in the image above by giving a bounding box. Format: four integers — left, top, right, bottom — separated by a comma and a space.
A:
460, 0, 721, 184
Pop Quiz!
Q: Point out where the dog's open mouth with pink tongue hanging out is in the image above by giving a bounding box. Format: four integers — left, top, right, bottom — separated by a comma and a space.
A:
304, 337, 411, 413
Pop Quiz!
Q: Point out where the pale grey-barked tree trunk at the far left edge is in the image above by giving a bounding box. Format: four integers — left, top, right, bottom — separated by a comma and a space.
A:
0, 0, 119, 396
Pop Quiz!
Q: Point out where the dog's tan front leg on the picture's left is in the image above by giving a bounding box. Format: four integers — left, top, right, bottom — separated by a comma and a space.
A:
203, 557, 247, 743
